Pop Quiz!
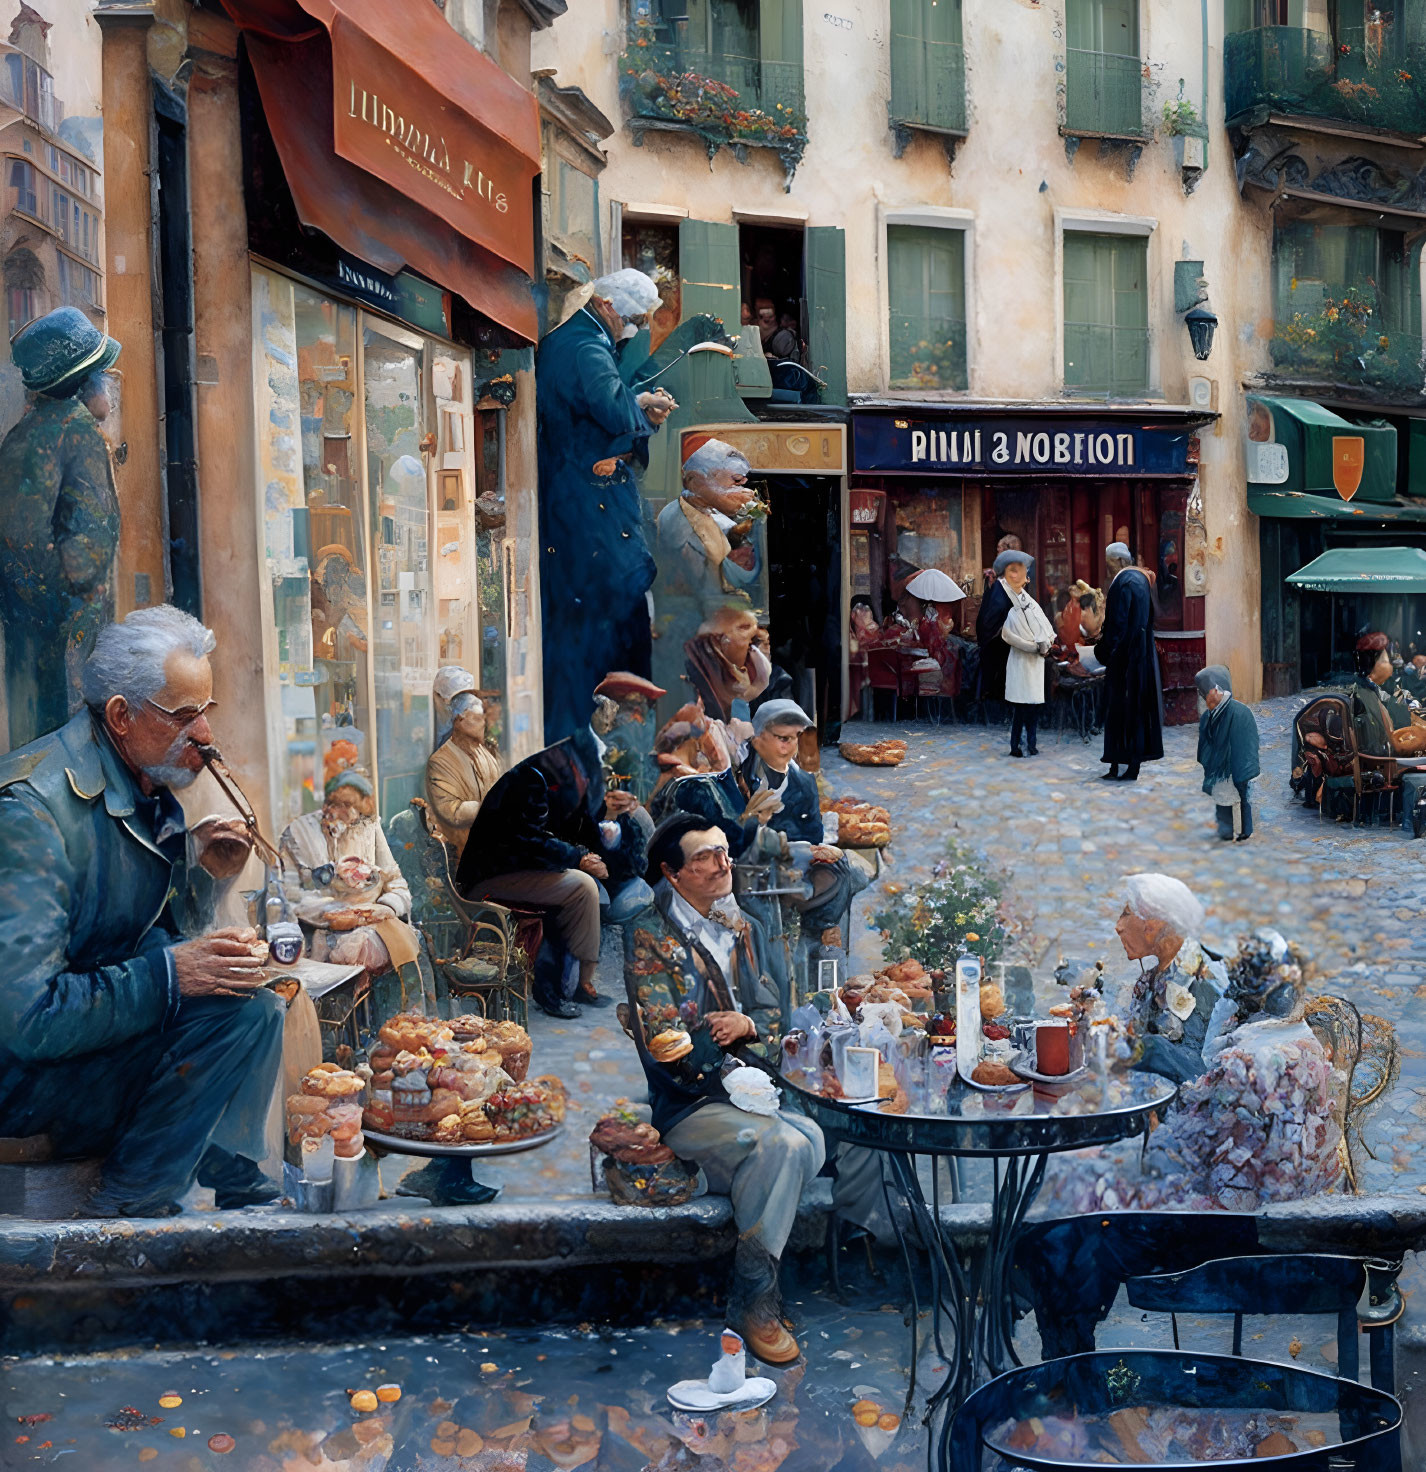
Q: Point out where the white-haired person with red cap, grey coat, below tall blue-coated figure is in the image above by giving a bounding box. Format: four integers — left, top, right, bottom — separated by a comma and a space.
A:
656, 440, 765, 618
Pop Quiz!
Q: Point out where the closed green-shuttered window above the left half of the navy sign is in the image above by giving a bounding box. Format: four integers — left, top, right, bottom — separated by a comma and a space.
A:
886, 225, 967, 389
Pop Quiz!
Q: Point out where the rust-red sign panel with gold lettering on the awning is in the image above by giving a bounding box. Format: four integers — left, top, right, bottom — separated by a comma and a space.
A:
331, 10, 539, 269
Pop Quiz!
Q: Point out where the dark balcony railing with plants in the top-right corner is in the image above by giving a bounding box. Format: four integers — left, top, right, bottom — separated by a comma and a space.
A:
1223, 25, 1426, 137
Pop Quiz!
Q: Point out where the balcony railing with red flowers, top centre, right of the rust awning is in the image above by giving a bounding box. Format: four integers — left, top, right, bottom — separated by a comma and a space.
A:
622, 21, 806, 172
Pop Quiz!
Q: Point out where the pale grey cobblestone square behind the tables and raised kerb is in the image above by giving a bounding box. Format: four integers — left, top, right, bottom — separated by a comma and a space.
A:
450, 688, 1426, 1200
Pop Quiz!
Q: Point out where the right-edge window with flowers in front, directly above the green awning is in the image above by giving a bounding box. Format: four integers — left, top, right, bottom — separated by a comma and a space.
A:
1273, 219, 1426, 397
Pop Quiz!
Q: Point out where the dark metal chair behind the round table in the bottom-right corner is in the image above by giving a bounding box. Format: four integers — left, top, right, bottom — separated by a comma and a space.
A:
1124, 1253, 1404, 1394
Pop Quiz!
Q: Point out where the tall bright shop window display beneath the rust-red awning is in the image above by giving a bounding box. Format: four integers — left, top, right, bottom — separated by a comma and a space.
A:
252, 268, 475, 824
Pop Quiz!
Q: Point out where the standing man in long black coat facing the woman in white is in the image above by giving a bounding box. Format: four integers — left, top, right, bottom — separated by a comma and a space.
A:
1095, 542, 1164, 782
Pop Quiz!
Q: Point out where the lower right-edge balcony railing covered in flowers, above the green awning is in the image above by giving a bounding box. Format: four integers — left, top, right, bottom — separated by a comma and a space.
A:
1273, 287, 1426, 400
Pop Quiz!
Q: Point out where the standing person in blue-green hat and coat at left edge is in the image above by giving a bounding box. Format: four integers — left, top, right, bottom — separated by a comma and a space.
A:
0, 306, 119, 748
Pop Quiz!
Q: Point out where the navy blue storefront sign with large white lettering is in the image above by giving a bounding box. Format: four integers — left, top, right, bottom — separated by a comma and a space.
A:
852, 415, 1192, 475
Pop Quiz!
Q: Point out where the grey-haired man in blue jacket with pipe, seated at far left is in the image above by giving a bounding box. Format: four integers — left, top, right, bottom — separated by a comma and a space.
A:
0, 606, 283, 1216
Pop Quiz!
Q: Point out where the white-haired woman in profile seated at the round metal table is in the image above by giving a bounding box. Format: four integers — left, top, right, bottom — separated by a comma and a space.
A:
1114, 874, 1227, 1083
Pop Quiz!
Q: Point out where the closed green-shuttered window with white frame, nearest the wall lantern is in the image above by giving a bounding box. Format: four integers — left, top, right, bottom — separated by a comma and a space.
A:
1064, 231, 1149, 399
